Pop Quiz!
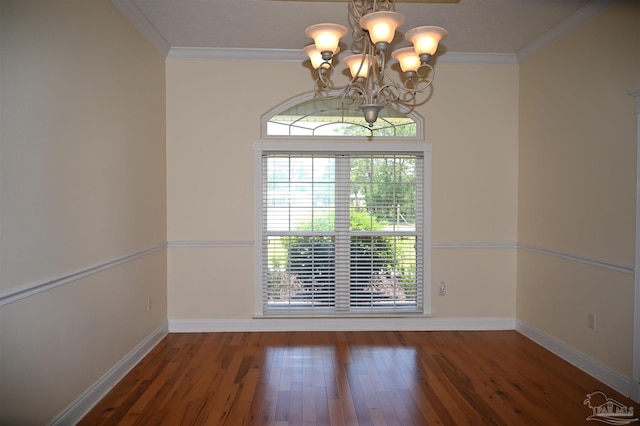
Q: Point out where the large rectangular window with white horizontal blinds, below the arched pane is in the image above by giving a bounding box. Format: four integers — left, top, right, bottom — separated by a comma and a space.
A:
256, 144, 430, 315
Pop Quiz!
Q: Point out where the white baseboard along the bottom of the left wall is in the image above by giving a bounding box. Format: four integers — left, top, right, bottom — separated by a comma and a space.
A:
50, 323, 168, 425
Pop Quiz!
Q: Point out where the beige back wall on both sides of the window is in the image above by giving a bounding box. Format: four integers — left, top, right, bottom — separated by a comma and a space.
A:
167, 60, 518, 320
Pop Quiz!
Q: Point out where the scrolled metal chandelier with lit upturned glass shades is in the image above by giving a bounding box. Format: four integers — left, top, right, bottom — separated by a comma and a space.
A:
303, 0, 448, 127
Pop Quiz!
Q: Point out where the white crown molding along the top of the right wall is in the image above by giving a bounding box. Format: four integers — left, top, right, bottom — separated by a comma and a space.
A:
516, 0, 619, 64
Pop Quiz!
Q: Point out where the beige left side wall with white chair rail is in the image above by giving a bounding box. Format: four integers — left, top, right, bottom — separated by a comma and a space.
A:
0, 0, 166, 424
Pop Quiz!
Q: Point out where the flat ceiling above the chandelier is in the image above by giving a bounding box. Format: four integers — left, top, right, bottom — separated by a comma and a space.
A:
112, 0, 614, 59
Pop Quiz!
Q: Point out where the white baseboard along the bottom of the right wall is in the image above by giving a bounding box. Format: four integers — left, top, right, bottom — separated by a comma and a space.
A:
516, 320, 633, 397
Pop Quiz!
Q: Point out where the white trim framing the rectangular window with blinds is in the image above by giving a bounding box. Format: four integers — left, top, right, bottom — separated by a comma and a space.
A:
253, 141, 432, 318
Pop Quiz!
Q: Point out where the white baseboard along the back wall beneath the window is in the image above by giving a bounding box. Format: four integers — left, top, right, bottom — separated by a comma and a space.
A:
169, 316, 516, 333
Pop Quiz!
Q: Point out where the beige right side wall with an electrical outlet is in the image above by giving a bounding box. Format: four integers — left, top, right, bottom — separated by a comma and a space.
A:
517, 0, 640, 377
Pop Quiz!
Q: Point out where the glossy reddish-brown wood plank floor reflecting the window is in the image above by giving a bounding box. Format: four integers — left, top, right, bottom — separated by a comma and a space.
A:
80, 331, 640, 426
